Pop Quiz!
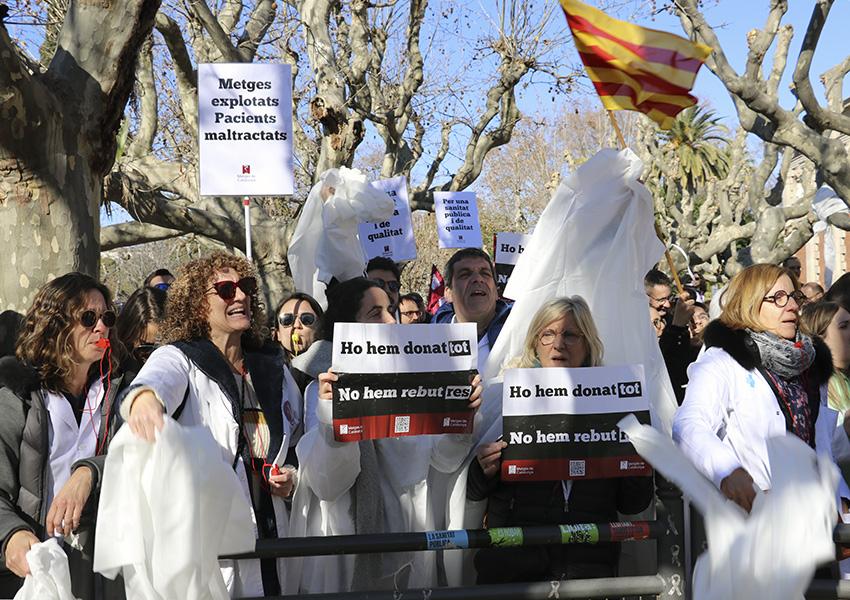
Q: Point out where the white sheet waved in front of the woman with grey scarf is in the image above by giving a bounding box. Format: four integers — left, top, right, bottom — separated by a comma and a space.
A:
619, 415, 838, 600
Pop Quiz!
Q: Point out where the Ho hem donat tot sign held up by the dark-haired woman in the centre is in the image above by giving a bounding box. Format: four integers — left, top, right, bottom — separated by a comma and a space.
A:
332, 323, 478, 442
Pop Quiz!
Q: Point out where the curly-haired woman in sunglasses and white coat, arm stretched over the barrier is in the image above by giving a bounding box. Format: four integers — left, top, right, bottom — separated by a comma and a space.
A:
121, 252, 301, 596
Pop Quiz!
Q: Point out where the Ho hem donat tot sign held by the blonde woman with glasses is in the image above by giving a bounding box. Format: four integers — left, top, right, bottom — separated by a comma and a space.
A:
502, 365, 652, 481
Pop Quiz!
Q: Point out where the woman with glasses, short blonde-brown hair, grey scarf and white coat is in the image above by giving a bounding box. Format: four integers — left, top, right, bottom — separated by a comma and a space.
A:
673, 264, 836, 512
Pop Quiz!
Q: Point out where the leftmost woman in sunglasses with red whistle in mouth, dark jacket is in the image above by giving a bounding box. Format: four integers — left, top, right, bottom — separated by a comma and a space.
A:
0, 273, 123, 599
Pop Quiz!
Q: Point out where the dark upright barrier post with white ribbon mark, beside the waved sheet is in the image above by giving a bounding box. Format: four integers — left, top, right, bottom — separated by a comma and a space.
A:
655, 471, 686, 600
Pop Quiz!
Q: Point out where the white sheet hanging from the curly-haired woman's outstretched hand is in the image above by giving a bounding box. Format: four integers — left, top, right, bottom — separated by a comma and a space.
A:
94, 419, 255, 600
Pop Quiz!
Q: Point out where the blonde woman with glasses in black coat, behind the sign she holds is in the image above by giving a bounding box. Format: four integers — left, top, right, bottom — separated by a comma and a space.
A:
466, 296, 653, 584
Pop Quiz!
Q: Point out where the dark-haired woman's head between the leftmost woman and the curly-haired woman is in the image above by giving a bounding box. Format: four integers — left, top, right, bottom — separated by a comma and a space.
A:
115, 287, 168, 374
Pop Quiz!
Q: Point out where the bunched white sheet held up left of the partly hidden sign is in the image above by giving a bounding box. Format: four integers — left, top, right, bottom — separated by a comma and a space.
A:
287, 167, 395, 307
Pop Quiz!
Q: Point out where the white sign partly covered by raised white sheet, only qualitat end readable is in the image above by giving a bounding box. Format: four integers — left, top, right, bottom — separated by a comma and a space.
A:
359, 175, 416, 262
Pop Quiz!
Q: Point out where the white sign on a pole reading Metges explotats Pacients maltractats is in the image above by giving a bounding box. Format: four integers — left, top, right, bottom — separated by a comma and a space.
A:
198, 63, 295, 196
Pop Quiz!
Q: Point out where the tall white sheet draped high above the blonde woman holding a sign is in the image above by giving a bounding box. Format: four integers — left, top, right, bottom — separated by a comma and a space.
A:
485, 149, 676, 433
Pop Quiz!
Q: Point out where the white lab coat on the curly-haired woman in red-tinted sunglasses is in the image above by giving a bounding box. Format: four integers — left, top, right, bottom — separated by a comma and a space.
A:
121, 345, 301, 596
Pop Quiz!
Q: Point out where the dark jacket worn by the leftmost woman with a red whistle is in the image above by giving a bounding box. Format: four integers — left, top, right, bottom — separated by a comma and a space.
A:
0, 357, 124, 598
